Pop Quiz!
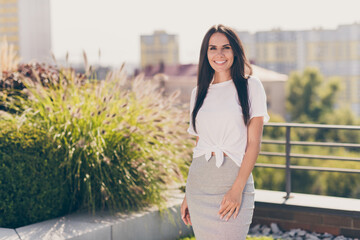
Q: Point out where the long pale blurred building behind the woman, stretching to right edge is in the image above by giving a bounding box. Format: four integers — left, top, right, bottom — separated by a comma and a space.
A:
238, 23, 360, 116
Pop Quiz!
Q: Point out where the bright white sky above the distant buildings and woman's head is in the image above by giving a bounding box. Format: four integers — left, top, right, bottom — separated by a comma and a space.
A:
50, 0, 360, 66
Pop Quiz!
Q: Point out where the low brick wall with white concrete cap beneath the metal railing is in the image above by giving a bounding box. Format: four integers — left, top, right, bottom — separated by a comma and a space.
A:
252, 190, 360, 237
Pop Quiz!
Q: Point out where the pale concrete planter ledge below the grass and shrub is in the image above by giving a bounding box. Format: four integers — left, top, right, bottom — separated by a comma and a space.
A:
0, 190, 192, 240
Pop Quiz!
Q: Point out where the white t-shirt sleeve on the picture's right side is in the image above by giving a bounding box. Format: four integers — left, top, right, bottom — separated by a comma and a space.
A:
248, 77, 270, 123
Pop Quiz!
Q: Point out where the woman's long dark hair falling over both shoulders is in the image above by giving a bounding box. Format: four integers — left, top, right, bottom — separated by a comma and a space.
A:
191, 24, 252, 132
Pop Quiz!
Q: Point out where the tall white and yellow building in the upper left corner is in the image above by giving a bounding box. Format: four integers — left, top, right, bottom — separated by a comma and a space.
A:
0, 0, 51, 62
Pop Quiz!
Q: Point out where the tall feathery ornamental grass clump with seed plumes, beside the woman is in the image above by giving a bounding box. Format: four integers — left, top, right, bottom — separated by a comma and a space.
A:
0, 49, 192, 227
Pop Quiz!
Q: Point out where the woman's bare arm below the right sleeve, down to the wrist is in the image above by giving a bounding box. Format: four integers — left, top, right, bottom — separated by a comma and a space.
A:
232, 117, 264, 192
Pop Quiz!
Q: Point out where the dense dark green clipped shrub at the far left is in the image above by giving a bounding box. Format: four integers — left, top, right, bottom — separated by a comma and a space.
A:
0, 121, 69, 228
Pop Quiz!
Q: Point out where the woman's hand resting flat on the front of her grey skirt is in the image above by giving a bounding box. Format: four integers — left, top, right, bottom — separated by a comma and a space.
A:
218, 189, 242, 221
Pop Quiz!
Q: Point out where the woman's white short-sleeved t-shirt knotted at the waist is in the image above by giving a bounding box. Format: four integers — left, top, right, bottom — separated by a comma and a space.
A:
187, 76, 270, 167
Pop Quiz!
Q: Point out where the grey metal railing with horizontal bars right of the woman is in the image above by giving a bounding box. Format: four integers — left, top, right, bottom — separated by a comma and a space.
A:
255, 123, 360, 199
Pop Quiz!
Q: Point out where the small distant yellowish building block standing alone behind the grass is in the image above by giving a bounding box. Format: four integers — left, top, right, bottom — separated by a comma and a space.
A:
140, 31, 179, 69
